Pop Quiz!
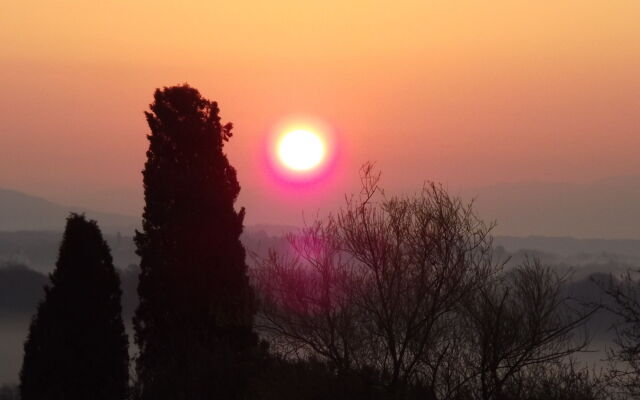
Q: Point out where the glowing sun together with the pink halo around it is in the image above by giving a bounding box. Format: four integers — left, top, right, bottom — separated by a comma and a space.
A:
265, 118, 338, 187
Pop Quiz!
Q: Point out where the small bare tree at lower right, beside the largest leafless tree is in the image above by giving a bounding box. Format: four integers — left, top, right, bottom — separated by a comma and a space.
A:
466, 259, 596, 400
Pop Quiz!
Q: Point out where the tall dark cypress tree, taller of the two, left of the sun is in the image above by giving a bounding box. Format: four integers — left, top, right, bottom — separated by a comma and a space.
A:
134, 84, 257, 400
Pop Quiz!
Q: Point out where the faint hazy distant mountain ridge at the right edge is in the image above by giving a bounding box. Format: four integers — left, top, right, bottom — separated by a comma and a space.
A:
463, 176, 640, 239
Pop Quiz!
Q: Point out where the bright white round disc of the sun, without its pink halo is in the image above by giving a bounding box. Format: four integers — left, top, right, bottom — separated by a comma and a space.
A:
277, 129, 326, 172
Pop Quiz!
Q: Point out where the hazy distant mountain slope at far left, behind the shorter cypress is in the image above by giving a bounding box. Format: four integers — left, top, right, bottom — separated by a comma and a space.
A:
0, 189, 140, 234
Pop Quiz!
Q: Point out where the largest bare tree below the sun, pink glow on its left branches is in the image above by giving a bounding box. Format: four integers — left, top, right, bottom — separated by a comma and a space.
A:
255, 165, 496, 393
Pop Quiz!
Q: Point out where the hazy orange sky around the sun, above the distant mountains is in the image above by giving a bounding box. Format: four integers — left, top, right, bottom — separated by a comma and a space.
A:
0, 0, 640, 228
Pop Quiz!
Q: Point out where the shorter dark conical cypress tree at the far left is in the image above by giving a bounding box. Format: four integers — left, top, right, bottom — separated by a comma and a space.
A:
20, 214, 129, 400
